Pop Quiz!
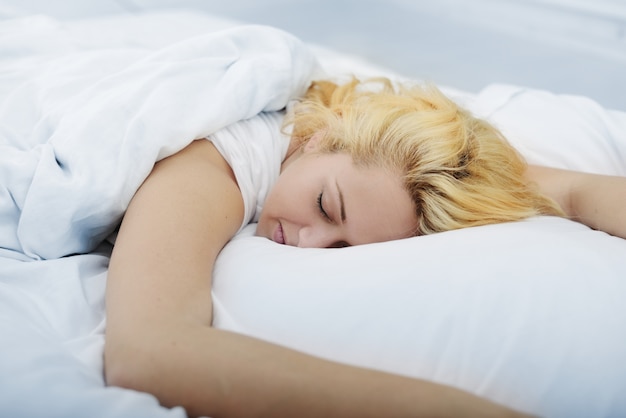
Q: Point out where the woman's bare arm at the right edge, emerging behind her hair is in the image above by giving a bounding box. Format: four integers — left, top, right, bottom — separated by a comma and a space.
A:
526, 166, 626, 239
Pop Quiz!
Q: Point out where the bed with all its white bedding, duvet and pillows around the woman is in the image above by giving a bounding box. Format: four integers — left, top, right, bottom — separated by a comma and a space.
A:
0, 7, 626, 418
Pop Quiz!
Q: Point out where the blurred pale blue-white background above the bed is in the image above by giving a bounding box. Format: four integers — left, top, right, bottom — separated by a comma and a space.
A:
0, 0, 626, 111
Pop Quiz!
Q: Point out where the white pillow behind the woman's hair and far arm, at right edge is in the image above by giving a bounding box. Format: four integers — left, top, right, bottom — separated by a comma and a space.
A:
468, 84, 626, 176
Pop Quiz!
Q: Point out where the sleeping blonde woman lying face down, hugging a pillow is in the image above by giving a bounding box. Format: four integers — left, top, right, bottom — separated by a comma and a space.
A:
105, 79, 626, 418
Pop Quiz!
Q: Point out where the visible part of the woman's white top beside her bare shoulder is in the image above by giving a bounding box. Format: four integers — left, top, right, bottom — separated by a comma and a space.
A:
207, 112, 290, 228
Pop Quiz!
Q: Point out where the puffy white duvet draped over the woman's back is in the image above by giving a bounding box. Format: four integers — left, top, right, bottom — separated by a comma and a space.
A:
0, 22, 318, 259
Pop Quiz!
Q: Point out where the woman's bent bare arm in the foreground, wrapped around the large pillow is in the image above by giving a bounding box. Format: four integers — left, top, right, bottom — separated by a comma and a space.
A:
105, 141, 532, 418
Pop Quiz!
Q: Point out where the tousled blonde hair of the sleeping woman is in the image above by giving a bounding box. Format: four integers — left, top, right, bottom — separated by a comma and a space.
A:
288, 78, 564, 235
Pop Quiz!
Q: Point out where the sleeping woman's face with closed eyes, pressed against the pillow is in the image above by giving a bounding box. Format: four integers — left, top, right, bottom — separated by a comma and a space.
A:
256, 145, 417, 248
